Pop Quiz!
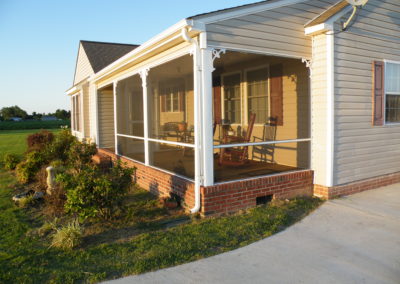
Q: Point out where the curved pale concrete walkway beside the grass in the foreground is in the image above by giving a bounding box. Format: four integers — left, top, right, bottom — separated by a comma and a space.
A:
107, 184, 400, 284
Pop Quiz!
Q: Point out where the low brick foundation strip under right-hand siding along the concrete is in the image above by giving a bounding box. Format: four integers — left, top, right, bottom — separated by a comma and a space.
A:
314, 173, 400, 199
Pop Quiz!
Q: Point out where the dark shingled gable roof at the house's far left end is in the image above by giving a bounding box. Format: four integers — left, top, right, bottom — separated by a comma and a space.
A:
80, 40, 139, 73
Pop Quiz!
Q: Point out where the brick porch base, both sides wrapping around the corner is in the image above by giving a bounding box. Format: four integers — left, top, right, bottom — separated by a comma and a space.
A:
95, 149, 313, 215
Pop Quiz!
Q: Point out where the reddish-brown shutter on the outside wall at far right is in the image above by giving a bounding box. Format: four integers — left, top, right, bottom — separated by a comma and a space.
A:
372, 61, 385, 126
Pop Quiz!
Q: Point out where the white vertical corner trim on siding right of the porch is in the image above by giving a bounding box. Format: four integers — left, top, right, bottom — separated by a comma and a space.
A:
325, 33, 335, 187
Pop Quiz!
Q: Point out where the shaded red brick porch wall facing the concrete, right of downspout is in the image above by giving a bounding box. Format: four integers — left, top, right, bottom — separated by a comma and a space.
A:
201, 170, 313, 215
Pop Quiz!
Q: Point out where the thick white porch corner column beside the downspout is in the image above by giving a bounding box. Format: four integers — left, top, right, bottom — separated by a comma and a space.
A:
200, 39, 214, 186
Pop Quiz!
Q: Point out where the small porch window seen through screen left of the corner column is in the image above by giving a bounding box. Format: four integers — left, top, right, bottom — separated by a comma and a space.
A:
160, 86, 185, 112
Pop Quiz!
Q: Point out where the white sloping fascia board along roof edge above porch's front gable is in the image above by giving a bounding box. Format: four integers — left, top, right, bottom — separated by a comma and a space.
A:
194, 0, 307, 24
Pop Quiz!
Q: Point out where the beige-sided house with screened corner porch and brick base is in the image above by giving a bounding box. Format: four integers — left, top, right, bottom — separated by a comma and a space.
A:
66, 0, 400, 215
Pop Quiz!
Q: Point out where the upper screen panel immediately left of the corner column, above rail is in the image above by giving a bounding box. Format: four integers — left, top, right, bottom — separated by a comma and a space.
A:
148, 55, 194, 144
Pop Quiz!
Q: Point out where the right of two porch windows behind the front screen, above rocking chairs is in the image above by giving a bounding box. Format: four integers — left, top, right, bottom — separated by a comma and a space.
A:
247, 68, 269, 123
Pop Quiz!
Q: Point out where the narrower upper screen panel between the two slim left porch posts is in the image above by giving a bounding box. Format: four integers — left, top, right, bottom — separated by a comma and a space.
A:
117, 75, 144, 137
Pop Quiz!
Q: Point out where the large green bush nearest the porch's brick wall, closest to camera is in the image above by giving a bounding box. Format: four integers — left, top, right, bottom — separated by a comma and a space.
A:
57, 163, 134, 219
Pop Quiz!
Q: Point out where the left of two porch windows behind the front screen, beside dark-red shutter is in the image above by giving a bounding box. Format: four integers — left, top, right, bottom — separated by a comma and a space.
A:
223, 73, 241, 123
